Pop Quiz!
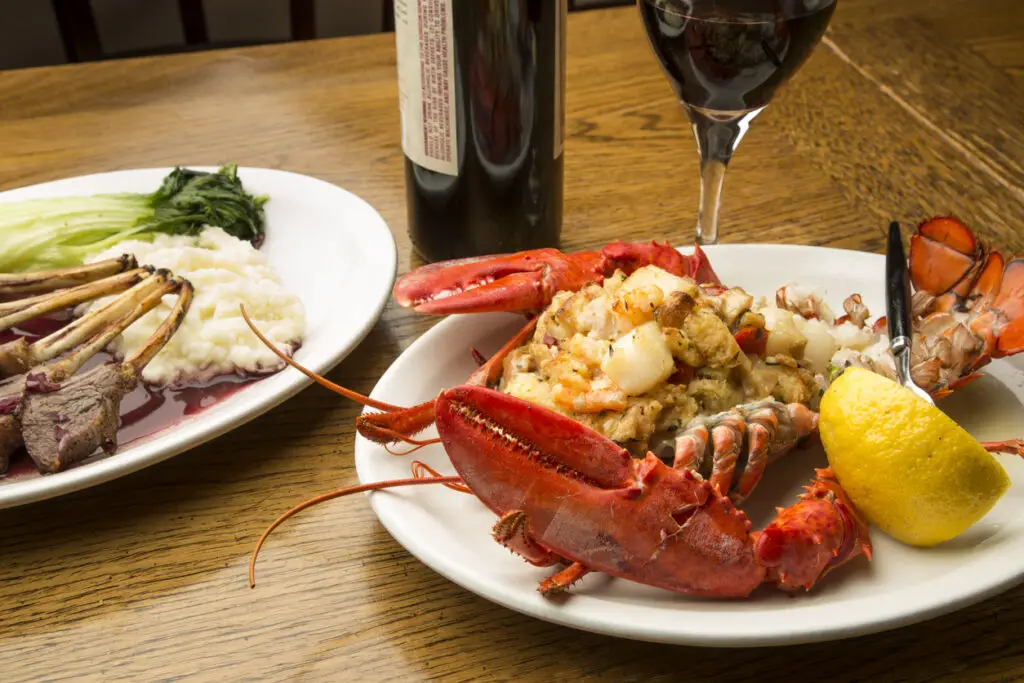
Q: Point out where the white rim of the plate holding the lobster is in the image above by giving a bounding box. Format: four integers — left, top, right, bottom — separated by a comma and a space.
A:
354, 243, 1024, 648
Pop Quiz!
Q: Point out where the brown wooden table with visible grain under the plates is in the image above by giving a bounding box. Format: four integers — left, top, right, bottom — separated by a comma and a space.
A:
0, 0, 1024, 683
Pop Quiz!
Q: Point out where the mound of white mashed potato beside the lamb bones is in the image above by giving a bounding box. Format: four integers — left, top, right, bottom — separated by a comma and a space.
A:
89, 227, 306, 385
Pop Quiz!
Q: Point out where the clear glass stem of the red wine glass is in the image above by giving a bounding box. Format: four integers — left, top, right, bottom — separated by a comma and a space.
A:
684, 104, 761, 245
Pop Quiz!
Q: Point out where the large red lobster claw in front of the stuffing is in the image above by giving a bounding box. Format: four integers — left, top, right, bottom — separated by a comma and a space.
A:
436, 385, 765, 597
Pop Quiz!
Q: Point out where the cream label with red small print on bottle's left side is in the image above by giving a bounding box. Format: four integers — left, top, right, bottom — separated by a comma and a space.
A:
394, 0, 459, 175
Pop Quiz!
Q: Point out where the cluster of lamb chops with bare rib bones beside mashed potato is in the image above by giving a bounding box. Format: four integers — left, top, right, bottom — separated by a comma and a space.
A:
0, 260, 193, 473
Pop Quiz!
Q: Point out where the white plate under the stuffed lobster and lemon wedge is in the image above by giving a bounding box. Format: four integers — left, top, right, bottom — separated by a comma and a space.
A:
355, 245, 1024, 646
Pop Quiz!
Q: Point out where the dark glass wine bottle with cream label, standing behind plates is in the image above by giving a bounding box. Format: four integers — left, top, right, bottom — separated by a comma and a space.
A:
394, 0, 567, 261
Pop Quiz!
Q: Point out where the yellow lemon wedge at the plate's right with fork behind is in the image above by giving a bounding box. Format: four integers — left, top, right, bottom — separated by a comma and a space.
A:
818, 368, 1010, 546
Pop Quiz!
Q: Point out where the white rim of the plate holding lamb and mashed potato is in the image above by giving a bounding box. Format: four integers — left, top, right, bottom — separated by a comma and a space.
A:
0, 164, 398, 510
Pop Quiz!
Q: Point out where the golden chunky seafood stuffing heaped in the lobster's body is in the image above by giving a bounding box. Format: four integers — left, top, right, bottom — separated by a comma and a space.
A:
499, 265, 886, 456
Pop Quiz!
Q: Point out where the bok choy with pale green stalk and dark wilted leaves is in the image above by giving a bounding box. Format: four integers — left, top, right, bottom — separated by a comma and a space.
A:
0, 164, 267, 272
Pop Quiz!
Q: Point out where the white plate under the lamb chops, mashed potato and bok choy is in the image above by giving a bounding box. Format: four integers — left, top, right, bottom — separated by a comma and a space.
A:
0, 167, 396, 508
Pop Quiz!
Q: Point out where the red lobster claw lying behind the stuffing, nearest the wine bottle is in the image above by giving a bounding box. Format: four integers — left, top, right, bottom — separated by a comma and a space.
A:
394, 242, 719, 314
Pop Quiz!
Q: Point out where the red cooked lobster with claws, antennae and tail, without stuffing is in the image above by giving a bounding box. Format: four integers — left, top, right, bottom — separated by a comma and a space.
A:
243, 219, 1024, 597
